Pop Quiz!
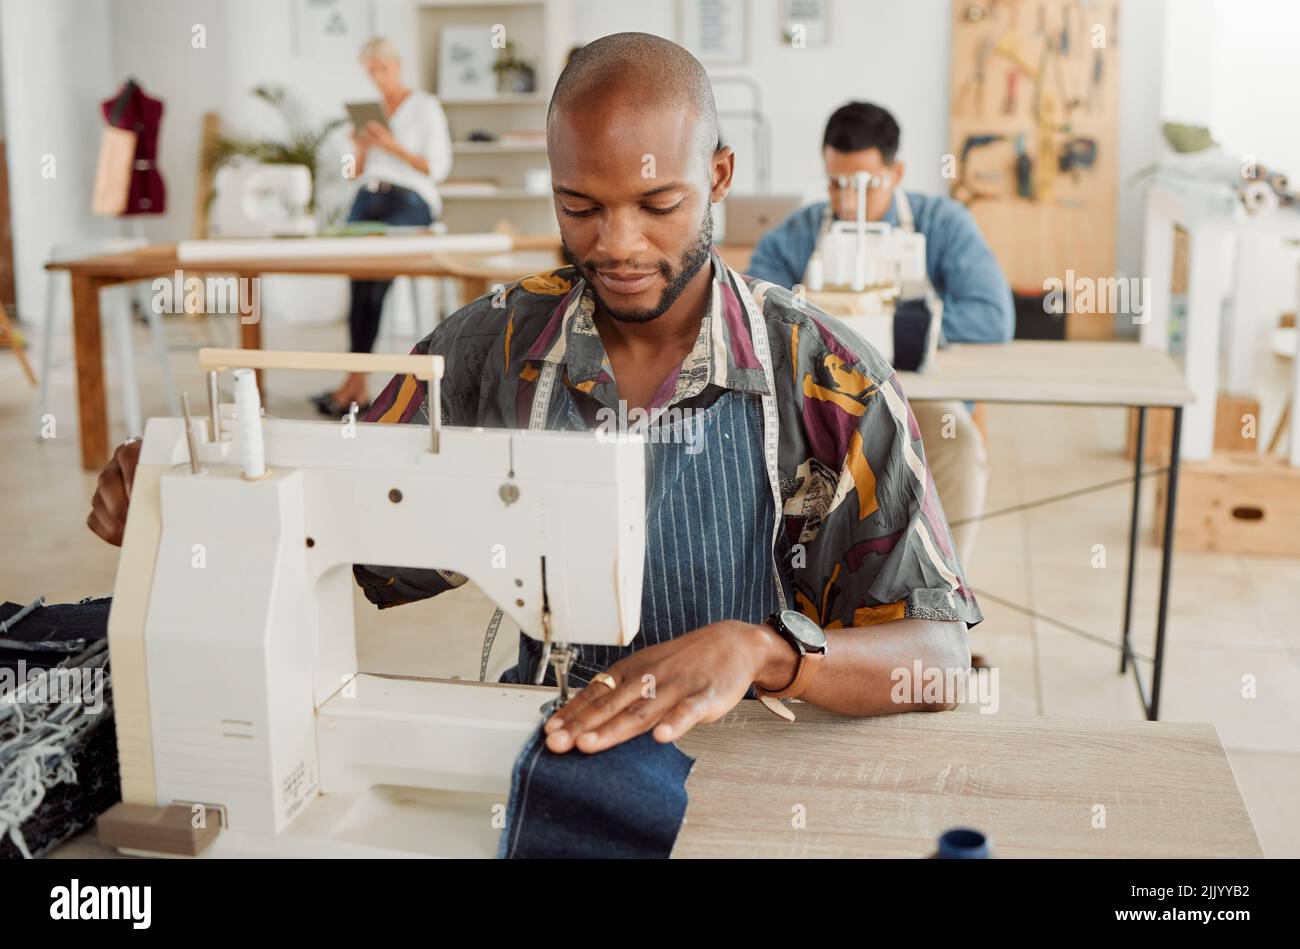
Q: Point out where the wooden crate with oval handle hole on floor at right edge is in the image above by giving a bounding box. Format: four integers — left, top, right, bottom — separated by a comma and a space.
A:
1156, 455, 1300, 556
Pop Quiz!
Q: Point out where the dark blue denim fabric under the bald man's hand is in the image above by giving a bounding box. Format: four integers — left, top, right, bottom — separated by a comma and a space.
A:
497, 728, 696, 859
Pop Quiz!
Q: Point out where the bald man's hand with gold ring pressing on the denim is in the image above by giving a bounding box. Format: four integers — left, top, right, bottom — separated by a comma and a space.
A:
545, 620, 797, 753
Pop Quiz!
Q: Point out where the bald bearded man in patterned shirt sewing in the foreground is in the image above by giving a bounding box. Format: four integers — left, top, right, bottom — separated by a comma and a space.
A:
90, 33, 980, 753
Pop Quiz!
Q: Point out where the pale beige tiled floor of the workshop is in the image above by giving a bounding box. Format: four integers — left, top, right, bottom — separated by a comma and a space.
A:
0, 315, 1300, 857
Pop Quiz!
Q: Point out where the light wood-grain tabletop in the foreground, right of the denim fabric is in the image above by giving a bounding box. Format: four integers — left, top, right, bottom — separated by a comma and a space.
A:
672, 702, 1262, 857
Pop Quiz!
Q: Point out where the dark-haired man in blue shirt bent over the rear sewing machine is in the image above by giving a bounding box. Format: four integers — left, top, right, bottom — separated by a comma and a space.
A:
748, 103, 1015, 568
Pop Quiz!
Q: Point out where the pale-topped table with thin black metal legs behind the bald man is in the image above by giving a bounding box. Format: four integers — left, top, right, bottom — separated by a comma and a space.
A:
898, 339, 1195, 720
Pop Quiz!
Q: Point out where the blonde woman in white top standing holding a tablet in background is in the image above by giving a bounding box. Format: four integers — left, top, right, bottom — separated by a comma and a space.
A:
312, 36, 451, 417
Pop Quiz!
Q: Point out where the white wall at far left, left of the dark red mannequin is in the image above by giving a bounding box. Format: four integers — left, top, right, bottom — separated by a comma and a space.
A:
0, 0, 118, 319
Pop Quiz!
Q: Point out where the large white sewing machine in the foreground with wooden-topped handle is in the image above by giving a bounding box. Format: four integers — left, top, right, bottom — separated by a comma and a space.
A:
100, 350, 645, 855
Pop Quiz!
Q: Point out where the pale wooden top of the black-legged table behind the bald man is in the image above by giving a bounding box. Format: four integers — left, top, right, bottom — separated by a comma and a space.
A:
898, 339, 1196, 407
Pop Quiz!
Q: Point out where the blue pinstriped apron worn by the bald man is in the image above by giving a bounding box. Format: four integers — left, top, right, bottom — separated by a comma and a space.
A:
502, 387, 789, 697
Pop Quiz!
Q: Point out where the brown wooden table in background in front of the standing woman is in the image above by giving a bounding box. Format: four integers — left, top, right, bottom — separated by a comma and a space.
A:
46, 235, 559, 471
